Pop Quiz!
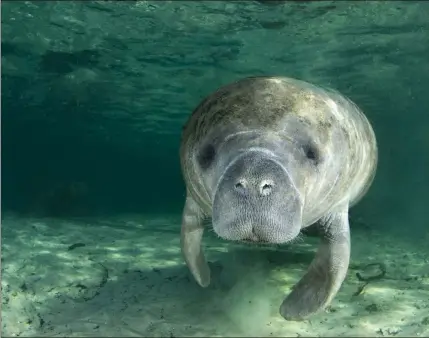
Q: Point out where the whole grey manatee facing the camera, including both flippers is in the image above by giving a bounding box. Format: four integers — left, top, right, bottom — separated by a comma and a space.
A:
180, 77, 377, 320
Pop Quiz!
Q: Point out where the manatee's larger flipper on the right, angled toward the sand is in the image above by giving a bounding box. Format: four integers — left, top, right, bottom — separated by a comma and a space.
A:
280, 205, 350, 320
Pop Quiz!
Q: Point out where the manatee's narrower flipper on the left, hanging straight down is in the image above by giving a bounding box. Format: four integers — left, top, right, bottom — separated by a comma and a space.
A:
180, 194, 210, 287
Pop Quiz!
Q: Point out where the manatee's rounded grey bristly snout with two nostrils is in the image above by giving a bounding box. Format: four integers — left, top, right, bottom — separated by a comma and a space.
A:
212, 151, 303, 243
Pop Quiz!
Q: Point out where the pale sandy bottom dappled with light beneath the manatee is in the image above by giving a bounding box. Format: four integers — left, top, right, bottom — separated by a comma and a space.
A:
1, 215, 429, 337
